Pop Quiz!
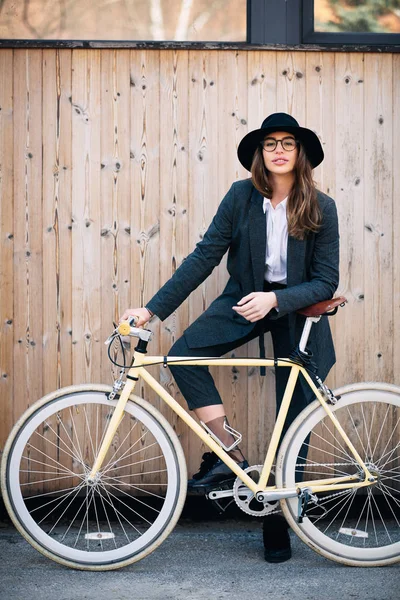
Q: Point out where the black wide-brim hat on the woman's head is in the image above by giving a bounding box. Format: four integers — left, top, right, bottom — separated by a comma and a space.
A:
238, 113, 324, 171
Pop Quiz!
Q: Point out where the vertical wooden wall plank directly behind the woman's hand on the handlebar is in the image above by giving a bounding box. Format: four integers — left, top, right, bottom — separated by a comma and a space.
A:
130, 51, 162, 424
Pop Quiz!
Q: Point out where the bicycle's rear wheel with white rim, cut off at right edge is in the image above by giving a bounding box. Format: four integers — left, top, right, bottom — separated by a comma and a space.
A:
276, 383, 400, 567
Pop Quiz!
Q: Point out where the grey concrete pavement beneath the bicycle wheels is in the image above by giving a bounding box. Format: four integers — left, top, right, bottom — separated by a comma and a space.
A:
0, 510, 400, 600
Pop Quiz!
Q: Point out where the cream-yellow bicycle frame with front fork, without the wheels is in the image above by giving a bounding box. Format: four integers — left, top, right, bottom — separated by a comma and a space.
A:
89, 351, 375, 497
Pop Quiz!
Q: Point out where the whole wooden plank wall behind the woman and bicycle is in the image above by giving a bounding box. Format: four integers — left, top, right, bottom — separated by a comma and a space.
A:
0, 50, 400, 472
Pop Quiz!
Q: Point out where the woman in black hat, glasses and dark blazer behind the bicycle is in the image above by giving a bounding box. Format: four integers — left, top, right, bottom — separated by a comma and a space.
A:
122, 113, 339, 561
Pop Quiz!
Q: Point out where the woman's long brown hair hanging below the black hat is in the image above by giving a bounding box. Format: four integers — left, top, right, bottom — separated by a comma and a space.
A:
251, 143, 322, 240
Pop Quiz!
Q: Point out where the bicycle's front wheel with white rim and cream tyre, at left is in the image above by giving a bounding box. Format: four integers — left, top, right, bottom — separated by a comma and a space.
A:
2, 386, 187, 570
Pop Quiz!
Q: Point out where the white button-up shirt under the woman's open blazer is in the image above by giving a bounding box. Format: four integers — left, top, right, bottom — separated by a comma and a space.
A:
263, 198, 288, 283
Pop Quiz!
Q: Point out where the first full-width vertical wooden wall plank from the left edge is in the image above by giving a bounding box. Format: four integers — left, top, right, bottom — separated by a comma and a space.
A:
13, 50, 43, 419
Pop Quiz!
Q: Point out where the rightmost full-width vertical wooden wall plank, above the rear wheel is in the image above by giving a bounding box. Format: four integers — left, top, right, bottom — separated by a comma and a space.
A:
364, 54, 393, 381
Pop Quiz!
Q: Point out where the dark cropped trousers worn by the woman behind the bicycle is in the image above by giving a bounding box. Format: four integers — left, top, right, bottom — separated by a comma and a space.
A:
169, 288, 309, 436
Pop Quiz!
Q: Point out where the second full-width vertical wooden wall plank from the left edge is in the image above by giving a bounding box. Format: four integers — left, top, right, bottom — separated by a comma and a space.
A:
43, 50, 72, 393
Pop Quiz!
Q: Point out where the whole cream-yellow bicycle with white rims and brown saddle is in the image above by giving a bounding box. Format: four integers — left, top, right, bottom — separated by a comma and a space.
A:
1, 297, 400, 570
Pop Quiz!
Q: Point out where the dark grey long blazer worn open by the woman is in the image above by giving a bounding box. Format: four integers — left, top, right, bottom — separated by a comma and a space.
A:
146, 179, 339, 378
